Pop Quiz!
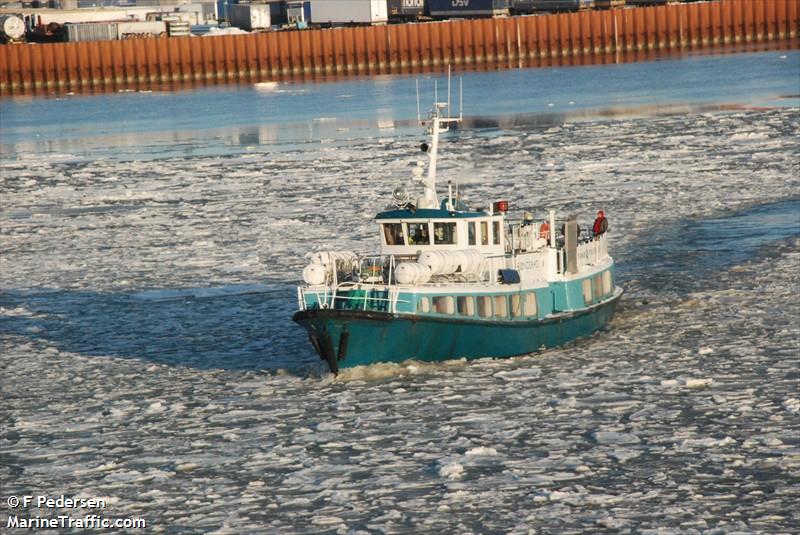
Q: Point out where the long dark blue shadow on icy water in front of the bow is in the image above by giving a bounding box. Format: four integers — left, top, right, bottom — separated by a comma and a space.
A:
0, 283, 320, 375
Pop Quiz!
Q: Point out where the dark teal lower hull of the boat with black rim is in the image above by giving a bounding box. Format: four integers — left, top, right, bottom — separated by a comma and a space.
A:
292, 289, 622, 373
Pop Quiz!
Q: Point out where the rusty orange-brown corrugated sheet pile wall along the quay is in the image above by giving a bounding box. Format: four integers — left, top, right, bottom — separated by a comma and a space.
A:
0, 0, 800, 94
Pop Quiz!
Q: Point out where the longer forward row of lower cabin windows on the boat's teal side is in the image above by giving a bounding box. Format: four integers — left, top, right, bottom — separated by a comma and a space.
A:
417, 292, 539, 318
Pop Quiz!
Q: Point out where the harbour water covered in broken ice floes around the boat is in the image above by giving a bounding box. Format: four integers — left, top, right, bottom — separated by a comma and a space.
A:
0, 51, 800, 534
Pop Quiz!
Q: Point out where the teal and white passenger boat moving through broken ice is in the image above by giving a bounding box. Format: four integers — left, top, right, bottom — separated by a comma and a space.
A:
292, 91, 623, 374
